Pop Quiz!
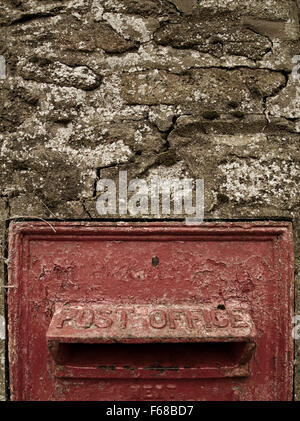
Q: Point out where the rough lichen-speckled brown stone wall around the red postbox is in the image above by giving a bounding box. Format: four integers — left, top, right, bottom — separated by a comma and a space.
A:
0, 0, 300, 400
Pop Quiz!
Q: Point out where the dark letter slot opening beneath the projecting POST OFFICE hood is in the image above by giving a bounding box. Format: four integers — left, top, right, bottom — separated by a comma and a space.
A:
48, 342, 255, 378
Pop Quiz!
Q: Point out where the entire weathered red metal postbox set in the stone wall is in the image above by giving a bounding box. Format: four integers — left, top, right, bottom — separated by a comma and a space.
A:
8, 223, 293, 401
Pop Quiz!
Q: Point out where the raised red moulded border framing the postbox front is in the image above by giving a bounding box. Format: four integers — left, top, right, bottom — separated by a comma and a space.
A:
8, 222, 294, 400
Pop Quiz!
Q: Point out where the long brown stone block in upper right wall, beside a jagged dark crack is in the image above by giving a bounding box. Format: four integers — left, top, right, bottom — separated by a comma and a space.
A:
122, 69, 285, 113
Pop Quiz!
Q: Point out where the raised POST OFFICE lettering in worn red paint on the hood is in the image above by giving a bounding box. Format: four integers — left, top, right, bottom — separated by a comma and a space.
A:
53, 306, 251, 331
